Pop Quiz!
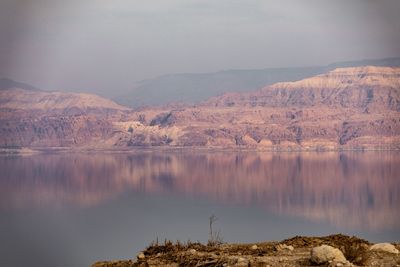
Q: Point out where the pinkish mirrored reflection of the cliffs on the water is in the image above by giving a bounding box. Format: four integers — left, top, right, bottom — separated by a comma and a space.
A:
0, 152, 400, 230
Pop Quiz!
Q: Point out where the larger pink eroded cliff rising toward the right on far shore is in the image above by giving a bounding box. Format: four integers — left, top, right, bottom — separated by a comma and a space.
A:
117, 67, 400, 149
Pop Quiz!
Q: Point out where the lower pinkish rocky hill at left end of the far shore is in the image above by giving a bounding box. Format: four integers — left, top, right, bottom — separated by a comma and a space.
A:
0, 80, 130, 147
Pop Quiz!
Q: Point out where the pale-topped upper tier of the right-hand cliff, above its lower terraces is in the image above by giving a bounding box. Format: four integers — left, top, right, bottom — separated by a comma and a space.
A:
207, 67, 400, 112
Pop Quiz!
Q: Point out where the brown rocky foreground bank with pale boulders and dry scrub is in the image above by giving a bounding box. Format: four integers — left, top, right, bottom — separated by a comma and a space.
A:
92, 235, 400, 267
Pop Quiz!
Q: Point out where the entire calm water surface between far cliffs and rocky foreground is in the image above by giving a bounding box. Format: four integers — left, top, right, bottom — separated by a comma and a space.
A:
0, 152, 400, 267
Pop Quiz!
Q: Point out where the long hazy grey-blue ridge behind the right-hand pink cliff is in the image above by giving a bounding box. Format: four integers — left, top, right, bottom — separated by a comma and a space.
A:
115, 58, 400, 107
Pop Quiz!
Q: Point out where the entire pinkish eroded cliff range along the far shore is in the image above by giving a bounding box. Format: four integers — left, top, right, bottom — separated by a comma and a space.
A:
0, 67, 400, 150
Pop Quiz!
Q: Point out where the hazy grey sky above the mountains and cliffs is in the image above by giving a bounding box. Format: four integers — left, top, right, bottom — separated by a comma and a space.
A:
0, 0, 400, 92
